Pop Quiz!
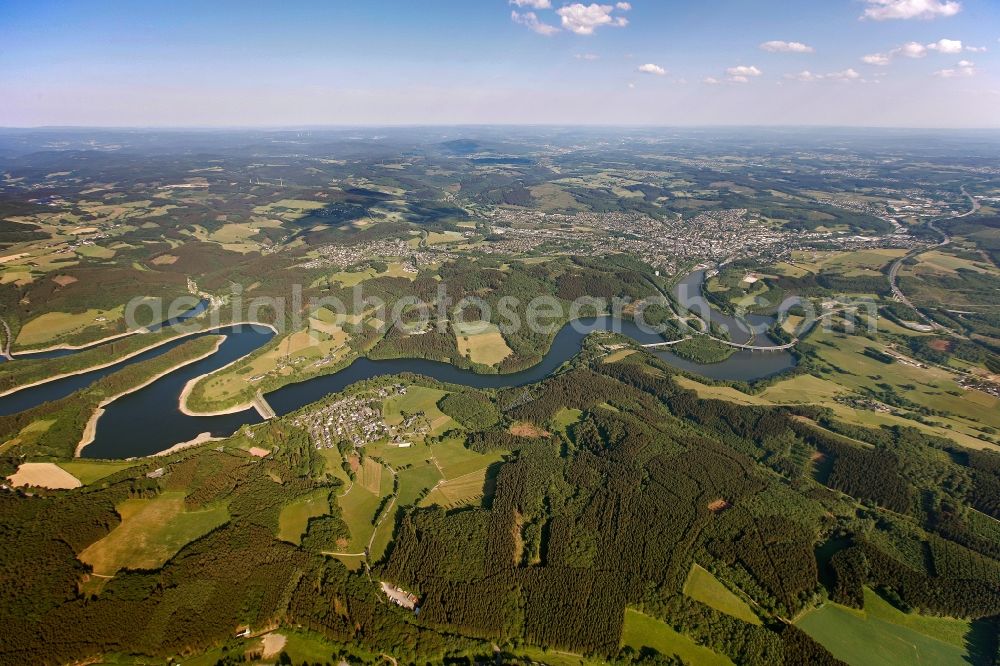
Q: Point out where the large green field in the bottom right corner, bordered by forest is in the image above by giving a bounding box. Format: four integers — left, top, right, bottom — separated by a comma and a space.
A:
795, 589, 984, 666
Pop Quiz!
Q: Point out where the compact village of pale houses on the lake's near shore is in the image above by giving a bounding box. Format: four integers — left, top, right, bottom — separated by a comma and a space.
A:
292, 384, 430, 449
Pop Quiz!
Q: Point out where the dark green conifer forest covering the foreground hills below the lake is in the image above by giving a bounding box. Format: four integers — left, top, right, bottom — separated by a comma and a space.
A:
0, 344, 1000, 664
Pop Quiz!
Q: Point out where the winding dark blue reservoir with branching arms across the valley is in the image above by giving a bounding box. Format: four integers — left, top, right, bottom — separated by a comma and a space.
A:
0, 273, 795, 458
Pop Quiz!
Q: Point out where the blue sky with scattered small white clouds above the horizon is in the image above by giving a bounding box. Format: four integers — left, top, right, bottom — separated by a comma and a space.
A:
0, 0, 1000, 127
